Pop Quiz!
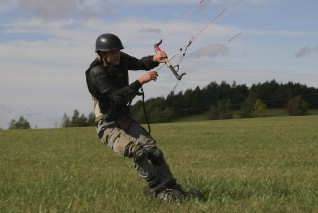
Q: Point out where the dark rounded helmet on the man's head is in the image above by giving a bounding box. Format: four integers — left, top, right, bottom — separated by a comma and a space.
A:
95, 33, 124, 53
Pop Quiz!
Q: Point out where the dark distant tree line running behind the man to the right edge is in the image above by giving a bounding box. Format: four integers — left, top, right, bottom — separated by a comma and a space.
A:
62, 80, 318, 127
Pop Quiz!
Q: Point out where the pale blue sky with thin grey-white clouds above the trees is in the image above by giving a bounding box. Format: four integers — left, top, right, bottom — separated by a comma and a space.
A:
0, 0, 318, 129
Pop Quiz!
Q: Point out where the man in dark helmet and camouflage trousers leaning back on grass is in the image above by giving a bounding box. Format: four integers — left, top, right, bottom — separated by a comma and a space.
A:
86, 33, 200, 202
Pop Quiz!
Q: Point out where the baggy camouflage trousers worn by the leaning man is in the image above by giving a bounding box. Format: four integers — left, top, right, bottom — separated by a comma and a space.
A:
97, 118, 173, 187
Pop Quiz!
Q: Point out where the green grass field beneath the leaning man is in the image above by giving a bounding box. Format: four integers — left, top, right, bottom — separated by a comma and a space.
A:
0, 116, 318, 212
